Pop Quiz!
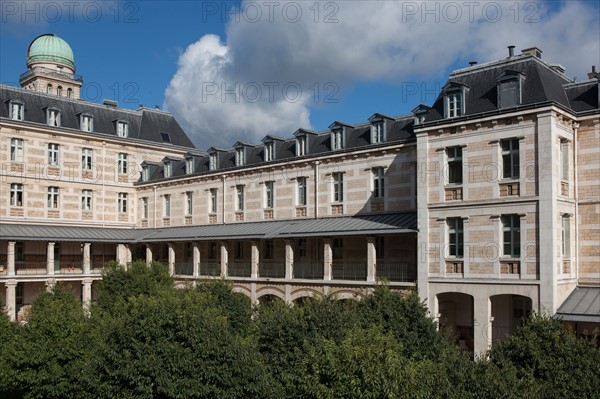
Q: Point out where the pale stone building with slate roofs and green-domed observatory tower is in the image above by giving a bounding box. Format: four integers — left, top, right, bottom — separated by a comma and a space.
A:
0, 35, 600, 353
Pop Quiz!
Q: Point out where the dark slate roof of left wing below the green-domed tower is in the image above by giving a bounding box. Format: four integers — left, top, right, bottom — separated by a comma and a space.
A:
0, 85, 194, 148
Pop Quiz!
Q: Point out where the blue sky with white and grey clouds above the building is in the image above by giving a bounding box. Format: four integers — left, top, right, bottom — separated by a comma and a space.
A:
0, 0, 600, 149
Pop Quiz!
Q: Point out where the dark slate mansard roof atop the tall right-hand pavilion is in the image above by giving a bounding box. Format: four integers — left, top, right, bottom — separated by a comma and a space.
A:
425, 54, 599, 124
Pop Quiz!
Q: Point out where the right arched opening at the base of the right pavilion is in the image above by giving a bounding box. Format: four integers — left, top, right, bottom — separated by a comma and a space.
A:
490, 294, 532, 345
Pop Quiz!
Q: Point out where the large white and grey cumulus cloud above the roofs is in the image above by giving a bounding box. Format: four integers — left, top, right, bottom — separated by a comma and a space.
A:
165, 1, 600, 148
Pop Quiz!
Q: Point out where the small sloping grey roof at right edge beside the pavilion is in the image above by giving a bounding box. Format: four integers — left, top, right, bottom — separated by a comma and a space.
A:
555, 287, 600, 323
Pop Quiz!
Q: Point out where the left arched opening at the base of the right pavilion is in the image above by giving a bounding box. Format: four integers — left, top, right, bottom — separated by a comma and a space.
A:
437, 292, 473, 352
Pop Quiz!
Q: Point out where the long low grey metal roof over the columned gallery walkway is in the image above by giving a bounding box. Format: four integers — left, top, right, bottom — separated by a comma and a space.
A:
0, 212, 417, 243
